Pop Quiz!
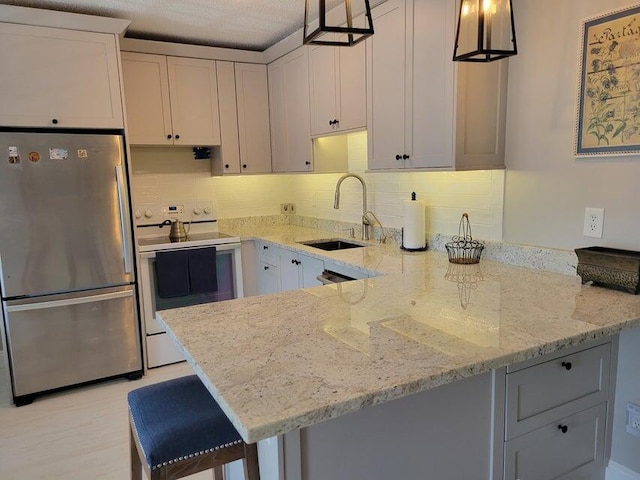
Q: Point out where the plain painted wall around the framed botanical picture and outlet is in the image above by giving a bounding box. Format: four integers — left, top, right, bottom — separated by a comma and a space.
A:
503, 0, 640, 250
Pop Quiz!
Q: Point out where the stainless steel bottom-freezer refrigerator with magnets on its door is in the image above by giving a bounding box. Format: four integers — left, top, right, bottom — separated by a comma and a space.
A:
0, 131, 142, 405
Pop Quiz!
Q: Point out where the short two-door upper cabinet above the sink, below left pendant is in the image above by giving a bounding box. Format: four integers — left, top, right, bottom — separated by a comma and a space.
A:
309, 39, 367, 136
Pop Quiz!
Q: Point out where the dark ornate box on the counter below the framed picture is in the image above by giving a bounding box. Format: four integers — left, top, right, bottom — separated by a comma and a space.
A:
575, 247, 640, 295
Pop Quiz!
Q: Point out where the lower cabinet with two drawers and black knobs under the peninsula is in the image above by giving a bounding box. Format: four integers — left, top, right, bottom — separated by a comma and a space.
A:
504, 341, 614, 480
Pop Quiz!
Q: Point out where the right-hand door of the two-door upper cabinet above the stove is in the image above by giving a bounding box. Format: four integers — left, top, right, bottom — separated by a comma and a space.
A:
167, 57, 220, 145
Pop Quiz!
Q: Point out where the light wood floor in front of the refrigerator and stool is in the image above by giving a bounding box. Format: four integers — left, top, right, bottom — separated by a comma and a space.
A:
0, 363, 213, 480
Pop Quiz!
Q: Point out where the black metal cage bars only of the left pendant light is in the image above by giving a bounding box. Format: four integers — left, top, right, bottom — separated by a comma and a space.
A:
303, 0, 373, 47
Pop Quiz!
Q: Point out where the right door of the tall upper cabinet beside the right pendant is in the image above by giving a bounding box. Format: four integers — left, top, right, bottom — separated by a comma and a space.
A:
404, 0, 456, 168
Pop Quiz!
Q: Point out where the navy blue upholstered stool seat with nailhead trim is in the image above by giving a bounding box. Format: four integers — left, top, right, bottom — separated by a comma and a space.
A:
128, 375, 242, 470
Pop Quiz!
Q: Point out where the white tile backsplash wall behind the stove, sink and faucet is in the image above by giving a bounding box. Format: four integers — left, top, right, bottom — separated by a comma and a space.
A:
132, 133, 504, 240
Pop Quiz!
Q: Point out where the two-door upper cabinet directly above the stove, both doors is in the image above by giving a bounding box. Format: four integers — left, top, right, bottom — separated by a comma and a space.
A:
122, 52, 220, 145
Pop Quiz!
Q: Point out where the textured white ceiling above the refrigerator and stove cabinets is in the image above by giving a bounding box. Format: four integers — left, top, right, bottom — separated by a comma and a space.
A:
0, 0, 360, 51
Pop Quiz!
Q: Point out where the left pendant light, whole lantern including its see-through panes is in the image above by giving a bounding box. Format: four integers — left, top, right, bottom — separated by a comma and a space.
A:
303, 0, 373, 47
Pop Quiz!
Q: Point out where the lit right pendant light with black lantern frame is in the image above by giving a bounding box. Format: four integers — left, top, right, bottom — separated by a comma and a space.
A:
453, 0, 518, 62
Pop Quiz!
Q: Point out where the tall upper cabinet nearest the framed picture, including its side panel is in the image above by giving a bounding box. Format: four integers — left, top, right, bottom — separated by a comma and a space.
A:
367, 0, 508, 170
